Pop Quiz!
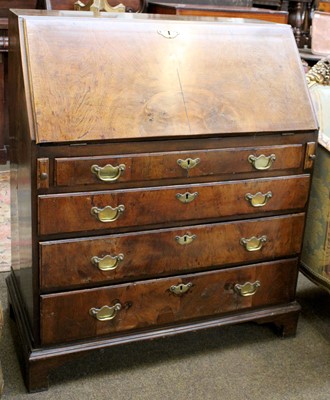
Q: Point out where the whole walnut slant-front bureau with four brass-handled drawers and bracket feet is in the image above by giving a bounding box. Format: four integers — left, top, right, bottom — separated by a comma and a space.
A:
7, 11, 317, 391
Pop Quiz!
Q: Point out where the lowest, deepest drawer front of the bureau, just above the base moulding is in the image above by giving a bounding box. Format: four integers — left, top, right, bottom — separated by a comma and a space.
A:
41, 259, 297, 345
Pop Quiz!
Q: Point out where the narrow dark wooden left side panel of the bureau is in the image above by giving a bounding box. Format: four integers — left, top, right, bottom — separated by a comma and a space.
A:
9, 11, 38, 333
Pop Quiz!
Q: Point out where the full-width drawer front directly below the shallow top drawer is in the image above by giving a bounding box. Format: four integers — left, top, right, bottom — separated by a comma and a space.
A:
38, 175, 310, 235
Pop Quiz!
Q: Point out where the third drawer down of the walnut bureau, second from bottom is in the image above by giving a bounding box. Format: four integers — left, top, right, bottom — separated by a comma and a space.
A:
39, 214, 305, 292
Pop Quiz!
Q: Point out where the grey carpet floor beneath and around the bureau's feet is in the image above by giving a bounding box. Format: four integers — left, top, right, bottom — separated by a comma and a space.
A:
0, 273, 330, 400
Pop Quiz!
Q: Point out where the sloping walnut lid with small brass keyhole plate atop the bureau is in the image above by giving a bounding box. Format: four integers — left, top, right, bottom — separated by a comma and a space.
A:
23, 13, 316, 143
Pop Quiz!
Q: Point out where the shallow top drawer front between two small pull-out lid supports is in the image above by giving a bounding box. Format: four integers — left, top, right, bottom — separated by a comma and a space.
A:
54, 144, 304, 187
